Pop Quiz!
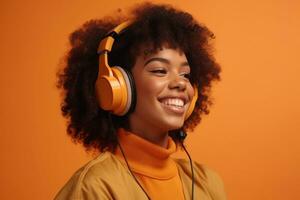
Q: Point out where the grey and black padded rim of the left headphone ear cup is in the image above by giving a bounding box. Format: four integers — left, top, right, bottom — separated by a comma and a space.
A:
112, 67, 136, 116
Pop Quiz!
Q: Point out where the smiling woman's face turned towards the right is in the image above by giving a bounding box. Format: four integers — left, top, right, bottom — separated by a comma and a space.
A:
129, 45, 194, 142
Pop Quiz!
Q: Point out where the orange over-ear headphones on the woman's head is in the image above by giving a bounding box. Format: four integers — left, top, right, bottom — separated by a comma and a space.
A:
95, 21, 198, 120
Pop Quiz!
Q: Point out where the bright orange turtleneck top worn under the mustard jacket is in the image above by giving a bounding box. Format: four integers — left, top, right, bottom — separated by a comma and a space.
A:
115, 129, 184, 200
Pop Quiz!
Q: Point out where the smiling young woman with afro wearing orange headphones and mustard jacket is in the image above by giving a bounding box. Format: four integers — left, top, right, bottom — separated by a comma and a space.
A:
55, 3, 226, 200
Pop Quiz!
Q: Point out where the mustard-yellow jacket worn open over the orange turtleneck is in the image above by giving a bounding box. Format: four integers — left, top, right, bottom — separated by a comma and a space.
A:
55, 152, 226, 200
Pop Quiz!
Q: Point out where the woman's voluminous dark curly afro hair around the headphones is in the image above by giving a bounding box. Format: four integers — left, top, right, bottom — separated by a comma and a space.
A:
57, 3, 221, 151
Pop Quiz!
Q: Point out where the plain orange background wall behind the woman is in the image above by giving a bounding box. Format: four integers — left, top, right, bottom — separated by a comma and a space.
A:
0, 0, 300, 200
